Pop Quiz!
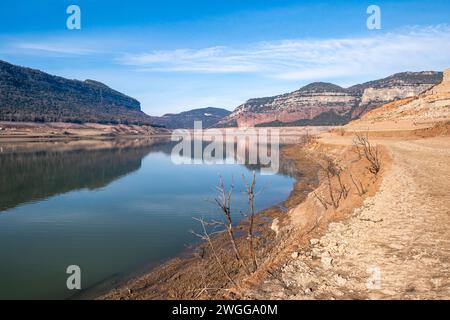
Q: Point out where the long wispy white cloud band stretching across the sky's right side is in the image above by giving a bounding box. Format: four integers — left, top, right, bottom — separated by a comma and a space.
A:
118, 25, 450, 80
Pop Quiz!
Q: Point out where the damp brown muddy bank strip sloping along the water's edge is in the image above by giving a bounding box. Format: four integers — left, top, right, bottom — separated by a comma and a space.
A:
99, 141, 318, 299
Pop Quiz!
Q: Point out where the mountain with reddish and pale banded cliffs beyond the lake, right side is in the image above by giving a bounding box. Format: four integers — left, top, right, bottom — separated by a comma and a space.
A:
218, 71, 442, 127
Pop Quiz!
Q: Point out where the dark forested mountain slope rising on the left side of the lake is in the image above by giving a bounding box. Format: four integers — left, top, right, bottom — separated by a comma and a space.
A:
0, 60, 161, 125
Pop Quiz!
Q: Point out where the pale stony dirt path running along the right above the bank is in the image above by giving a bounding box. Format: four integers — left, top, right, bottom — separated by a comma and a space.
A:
250, 137, 450, 299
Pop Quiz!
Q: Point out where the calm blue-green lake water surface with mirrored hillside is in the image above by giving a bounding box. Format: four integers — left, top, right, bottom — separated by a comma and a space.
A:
0, 142, 294, 299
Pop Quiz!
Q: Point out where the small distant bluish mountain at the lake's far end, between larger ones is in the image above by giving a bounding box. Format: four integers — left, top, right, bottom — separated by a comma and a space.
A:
157, 108, 231, 129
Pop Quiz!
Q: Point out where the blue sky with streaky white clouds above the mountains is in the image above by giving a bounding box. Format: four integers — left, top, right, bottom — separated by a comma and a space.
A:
0, 0, 450, 115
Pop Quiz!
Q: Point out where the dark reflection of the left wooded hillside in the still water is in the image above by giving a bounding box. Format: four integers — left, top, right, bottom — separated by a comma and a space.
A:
0, 141, 171, 211
